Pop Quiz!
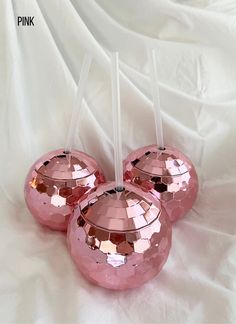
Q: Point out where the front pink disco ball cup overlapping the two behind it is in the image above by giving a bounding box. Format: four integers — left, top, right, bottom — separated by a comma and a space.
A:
67, 182, 171, 290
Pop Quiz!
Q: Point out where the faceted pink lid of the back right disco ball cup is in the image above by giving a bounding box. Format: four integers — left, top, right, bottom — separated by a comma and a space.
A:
126, 145, 192, 176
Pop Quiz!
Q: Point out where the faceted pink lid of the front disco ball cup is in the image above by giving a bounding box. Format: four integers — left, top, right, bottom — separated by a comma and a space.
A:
79, 182, 161, 232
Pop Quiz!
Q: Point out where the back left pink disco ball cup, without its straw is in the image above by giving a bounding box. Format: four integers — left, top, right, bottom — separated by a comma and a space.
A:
25, 149, 105, 231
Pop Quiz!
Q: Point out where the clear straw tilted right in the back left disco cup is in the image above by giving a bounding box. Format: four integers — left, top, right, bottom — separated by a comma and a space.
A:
65, 54, 92, 153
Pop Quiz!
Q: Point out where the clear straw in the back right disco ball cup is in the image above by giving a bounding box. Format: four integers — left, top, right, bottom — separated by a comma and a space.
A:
149, 49, 165, 149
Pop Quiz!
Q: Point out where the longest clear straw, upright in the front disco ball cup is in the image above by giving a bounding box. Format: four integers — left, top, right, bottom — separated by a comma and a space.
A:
111, 52, 124, 191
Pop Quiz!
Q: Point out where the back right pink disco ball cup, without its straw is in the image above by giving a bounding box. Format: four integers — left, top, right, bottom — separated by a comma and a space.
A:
124, 145, 198, 222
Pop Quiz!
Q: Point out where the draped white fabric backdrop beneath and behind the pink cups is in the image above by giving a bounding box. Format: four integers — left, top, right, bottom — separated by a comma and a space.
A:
0, 0, 236, 324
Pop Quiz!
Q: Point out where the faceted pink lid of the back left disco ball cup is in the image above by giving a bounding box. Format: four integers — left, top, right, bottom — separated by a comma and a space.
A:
35, 149, 98, 180
